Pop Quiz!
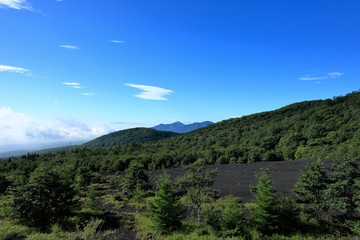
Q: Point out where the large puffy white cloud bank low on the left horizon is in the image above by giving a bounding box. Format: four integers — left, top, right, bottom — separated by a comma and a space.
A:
0, 107, 111, 146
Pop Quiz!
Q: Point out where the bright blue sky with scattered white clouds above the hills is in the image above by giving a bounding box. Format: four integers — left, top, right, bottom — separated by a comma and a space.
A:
0, 0, 360, 147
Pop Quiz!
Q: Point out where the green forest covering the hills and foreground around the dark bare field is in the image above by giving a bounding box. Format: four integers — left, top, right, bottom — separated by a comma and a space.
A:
0, 92, 360, 240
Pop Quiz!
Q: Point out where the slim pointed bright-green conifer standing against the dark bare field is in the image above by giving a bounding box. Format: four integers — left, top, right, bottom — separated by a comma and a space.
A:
251, 169, 278, 234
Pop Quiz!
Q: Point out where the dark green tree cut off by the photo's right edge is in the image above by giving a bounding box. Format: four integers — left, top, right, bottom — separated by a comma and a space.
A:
325, 159, 360, 218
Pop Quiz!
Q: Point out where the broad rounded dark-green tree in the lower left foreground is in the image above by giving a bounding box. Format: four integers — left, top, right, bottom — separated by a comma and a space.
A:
10, 166, 76, 229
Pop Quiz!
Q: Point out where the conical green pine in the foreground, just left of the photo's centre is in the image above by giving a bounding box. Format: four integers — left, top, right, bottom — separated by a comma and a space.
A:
149, 174, 182, 234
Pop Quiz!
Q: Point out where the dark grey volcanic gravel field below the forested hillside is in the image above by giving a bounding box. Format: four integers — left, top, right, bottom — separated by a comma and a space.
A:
148, 160, 332, 202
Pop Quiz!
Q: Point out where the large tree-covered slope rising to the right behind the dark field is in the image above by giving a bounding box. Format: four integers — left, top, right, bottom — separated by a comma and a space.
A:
159, 92, 360, 163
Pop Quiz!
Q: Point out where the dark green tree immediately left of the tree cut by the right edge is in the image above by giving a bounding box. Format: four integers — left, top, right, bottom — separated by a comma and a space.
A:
293, 160, 329, 220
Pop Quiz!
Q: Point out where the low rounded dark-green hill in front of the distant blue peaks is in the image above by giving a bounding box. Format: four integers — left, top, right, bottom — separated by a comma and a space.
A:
81, 128, 177, 148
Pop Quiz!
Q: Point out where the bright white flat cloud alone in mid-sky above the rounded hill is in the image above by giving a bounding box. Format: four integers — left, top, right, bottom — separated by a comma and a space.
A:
125, 83, 174, 100
